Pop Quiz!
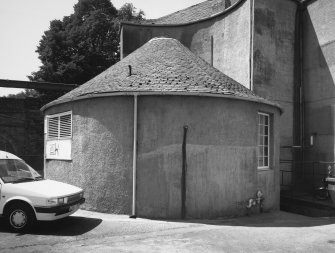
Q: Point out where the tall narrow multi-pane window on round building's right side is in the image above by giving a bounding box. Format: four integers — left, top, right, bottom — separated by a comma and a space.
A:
258, 113, 270, 169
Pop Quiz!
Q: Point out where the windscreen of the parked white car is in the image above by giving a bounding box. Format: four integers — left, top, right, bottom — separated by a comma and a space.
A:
0, 159, 42, 183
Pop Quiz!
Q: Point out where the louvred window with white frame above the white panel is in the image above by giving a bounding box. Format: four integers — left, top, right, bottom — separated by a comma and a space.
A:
47, 112, 72, 139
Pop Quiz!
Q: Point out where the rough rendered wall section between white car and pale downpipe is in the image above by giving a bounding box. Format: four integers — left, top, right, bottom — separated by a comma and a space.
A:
46, 97, 133, 214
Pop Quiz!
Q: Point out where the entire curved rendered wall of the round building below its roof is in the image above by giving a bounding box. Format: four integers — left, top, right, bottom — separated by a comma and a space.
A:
46, 96, 279, 218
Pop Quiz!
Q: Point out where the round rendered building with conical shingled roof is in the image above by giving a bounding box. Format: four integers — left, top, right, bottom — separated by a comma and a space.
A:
42, 38, 281, 218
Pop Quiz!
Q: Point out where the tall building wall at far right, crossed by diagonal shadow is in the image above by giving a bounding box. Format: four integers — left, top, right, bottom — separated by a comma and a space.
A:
303, 0, 335, 166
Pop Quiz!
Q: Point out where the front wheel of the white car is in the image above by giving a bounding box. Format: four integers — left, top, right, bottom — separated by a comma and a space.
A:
6, 203, 36, 233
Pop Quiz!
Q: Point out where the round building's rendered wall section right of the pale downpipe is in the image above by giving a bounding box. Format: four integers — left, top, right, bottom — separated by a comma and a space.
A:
137, 96, 279, 218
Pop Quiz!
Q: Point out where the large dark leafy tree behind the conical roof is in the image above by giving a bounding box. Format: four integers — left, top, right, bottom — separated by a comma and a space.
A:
28, 0, 144, 99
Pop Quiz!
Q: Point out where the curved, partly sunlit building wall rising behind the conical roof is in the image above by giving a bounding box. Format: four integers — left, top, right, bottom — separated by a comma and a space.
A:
121, 1, 250, 88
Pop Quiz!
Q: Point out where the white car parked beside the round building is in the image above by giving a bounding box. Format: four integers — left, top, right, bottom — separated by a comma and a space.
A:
0, 150, 85, 232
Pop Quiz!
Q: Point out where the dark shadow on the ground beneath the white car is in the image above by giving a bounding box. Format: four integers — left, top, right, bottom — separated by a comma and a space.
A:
0, 216, 102, 236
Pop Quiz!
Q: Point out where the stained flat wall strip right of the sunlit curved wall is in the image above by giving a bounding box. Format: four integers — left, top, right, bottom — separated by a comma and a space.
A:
252, 0, 299, 178
